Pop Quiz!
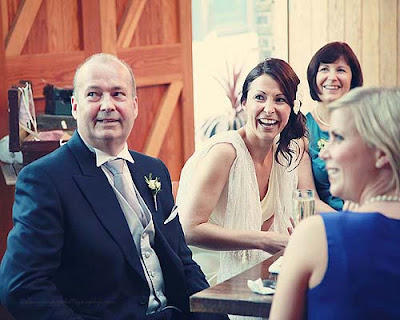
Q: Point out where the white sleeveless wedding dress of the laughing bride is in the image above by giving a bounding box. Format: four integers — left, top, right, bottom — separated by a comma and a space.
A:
177, 131, 297, 282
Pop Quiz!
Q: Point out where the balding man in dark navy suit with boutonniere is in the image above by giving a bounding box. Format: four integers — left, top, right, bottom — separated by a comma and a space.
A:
0, 54, 226, 320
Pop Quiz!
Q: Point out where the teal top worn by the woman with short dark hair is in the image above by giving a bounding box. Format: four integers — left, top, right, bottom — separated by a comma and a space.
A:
306, 113, 343, 211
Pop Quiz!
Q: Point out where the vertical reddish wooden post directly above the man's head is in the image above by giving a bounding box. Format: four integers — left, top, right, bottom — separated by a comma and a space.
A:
81, 0, 101, 58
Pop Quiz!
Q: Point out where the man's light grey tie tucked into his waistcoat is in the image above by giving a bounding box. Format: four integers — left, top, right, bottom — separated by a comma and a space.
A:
105, 158, 147, 227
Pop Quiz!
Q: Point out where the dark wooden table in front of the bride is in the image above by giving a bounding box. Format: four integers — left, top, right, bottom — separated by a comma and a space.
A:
190, 251, 283, 318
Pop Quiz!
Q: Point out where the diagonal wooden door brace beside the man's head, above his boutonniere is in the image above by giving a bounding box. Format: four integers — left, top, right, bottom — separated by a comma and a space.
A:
144, 81, 183, 157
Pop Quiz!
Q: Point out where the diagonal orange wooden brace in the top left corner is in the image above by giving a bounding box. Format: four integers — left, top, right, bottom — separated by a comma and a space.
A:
6, 0, 42, 56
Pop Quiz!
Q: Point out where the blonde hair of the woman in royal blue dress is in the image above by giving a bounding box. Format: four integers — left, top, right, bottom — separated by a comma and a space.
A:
328, 88, 400, 192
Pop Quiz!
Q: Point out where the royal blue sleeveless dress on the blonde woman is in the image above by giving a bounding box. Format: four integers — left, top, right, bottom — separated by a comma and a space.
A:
307, 212, 400, 320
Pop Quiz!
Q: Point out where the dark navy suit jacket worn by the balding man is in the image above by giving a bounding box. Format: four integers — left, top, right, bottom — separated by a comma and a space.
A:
0, 133, 227, 320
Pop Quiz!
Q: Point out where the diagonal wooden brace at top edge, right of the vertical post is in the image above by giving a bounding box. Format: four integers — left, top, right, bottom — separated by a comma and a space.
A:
117, 0, 146, 48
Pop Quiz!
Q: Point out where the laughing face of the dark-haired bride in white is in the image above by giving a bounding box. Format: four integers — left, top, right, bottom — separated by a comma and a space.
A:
243, 74, 291, 140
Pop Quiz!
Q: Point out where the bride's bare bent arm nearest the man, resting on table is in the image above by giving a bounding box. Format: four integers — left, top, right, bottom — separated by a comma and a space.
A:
179, 143, 288, 253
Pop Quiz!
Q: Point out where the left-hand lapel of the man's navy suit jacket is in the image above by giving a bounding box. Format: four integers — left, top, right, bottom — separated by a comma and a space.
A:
68, 133, 145, 280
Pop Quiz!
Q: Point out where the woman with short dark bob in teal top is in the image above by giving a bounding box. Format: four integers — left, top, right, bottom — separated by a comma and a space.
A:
306, 42, 363, 210
